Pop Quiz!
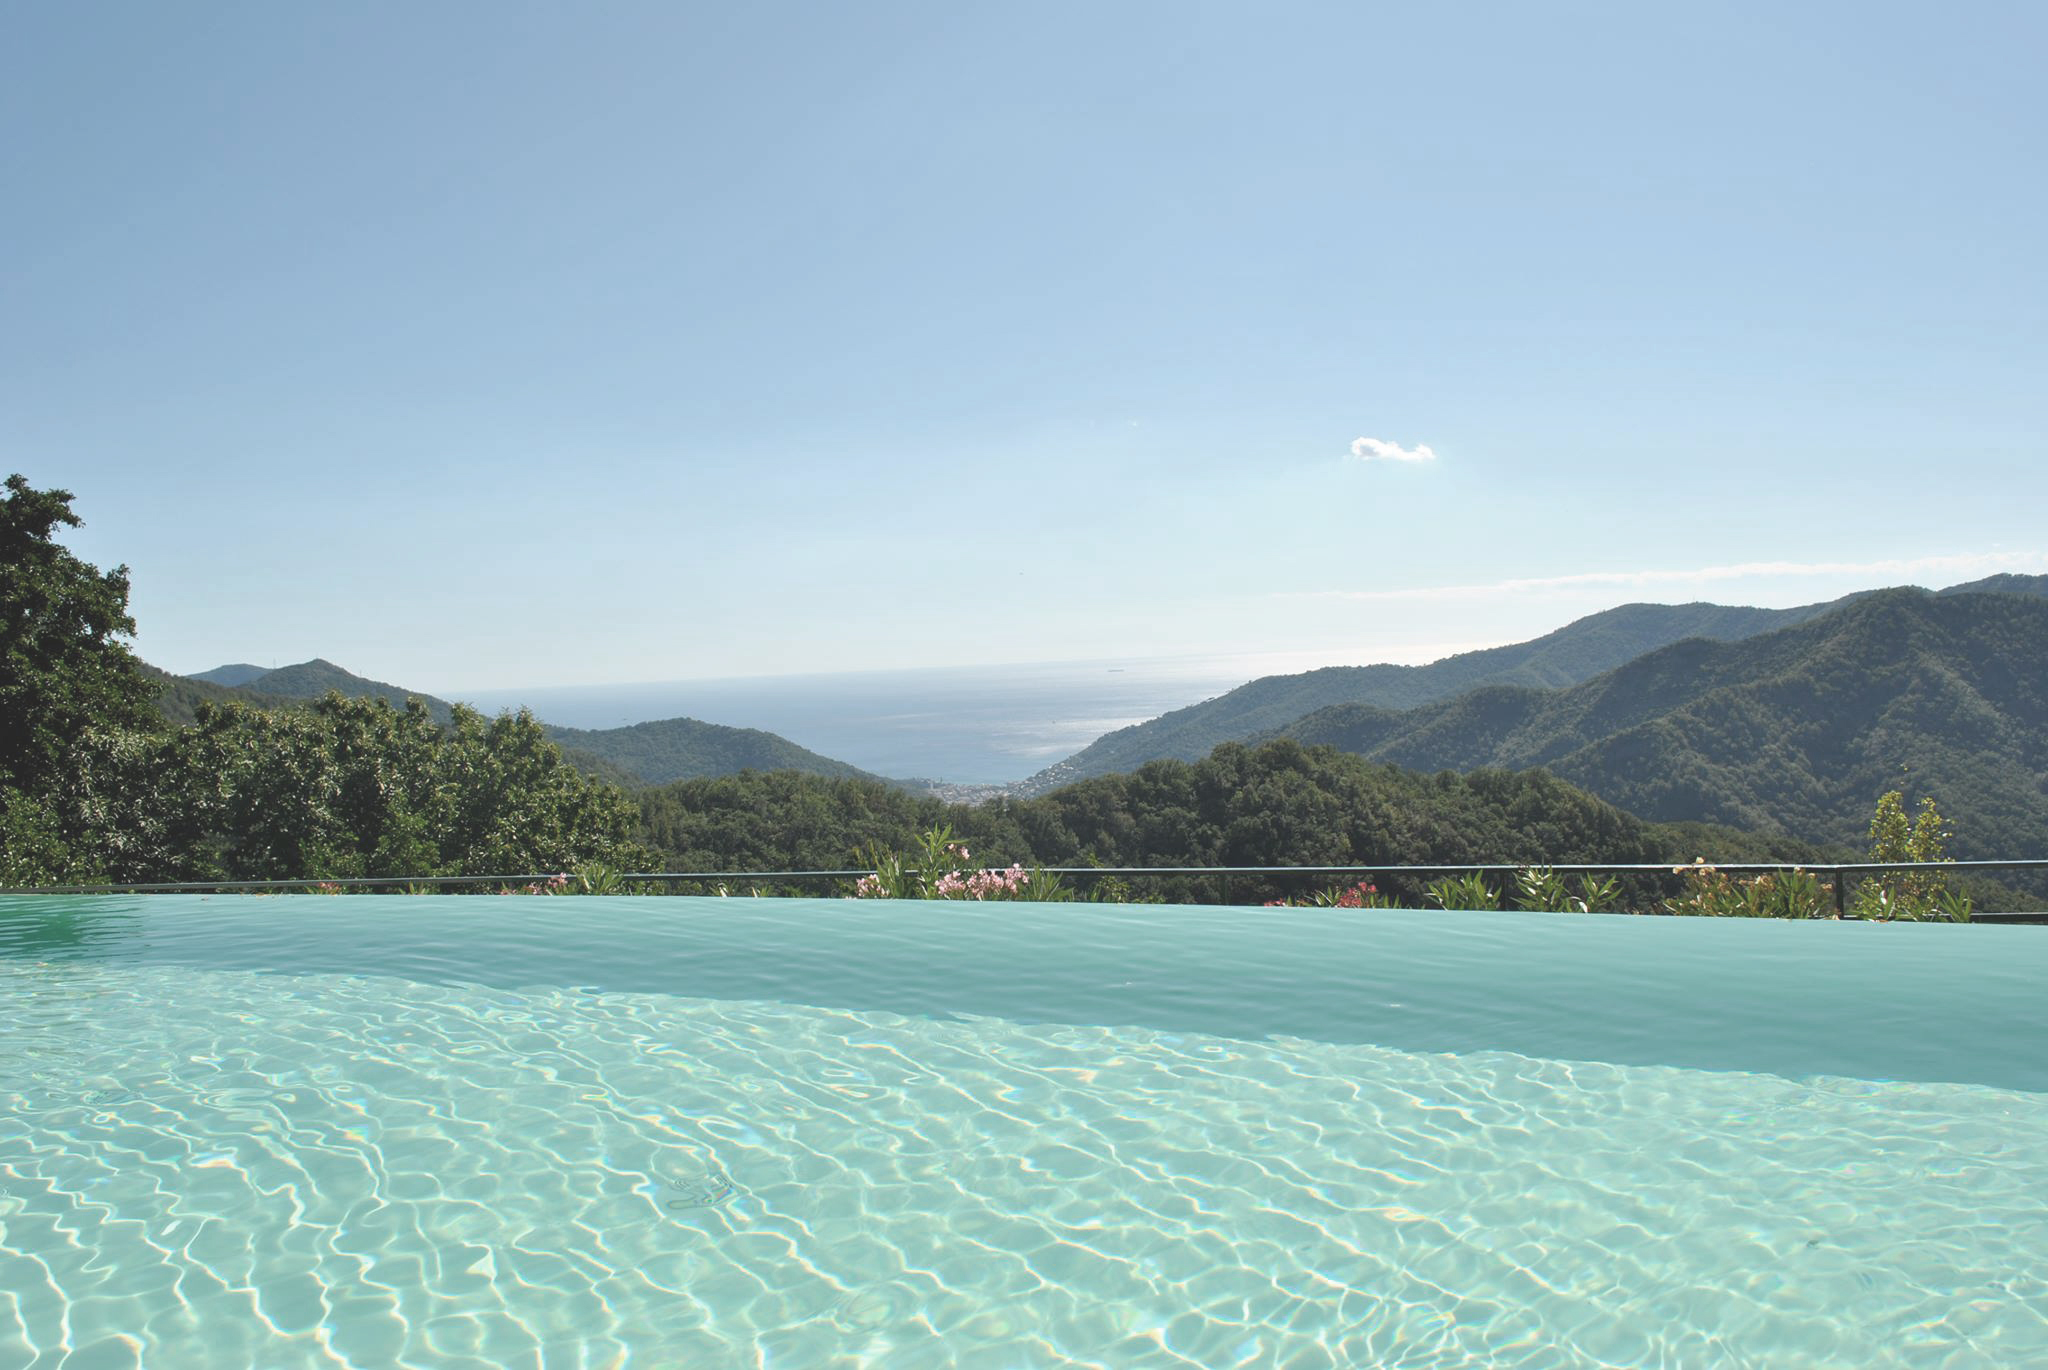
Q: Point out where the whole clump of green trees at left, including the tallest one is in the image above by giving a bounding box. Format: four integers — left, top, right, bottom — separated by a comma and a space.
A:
0, 475, 645, 885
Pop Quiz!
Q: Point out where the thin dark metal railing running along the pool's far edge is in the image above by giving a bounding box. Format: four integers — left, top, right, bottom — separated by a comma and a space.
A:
0, 858, 2048, 924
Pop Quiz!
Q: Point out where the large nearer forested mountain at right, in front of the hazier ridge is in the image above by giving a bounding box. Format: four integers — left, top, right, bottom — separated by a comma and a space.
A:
1276, 588, 2048, 858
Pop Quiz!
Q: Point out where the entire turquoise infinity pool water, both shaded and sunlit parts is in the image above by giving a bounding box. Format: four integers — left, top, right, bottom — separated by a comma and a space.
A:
0, 897, 2048, 1370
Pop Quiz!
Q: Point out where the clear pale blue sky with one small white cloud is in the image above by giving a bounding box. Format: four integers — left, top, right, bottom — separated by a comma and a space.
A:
0, 0, 2048, 694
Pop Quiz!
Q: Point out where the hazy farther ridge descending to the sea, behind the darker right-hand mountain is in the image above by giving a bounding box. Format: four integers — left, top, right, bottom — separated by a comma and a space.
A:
1010, 604, 1835, 797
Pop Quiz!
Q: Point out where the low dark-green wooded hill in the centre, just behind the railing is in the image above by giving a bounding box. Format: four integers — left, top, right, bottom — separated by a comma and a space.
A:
639, 741, 1819, 897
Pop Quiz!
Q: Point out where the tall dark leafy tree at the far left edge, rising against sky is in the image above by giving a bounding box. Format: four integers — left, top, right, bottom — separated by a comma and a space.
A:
0, 475, 162, 883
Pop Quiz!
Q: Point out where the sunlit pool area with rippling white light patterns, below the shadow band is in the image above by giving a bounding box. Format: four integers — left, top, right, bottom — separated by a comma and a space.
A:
0, 962, 2048, 1370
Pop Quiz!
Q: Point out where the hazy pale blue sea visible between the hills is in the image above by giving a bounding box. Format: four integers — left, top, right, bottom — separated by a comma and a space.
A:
451, 653, 1277, 784
